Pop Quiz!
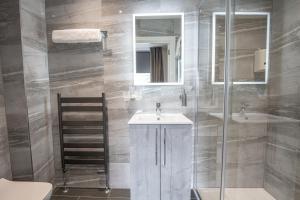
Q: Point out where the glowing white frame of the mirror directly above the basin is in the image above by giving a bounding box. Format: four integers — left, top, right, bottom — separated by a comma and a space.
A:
132, 13, 185, 86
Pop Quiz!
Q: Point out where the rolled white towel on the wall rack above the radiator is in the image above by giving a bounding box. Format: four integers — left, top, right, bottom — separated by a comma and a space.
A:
52, 29, 102, 43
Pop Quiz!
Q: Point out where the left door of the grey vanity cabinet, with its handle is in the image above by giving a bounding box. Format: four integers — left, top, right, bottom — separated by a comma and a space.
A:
130, 125, 160, 200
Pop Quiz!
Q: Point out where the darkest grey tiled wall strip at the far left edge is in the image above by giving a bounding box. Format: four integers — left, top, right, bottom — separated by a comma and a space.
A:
0, 0, 33, 180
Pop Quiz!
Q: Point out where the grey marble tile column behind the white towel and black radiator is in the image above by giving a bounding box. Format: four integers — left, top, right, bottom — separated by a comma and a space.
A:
46, 0, 104, 187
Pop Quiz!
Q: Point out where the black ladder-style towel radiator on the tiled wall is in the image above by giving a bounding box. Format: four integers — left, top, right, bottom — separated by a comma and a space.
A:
57, 93, 110, 192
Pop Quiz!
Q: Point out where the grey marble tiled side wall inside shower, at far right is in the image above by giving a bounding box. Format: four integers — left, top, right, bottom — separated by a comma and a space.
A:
264, 0, 300, 200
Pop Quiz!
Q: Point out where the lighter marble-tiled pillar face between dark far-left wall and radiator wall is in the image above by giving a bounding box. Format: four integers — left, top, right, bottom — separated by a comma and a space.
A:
20, 0, 54, 181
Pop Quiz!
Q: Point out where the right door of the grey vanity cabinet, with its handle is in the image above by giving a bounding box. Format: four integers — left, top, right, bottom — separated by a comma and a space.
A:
161, 125, 193, 200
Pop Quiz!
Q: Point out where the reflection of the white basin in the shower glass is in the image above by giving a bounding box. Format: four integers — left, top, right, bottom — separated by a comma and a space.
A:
209, 113, 300, 123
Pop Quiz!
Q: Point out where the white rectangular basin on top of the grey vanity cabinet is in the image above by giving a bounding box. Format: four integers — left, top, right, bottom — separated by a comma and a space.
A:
128, 113, 193, 125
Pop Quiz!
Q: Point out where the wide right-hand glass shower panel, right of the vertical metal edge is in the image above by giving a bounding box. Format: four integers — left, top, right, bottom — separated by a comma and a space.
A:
223, 0, 300, 200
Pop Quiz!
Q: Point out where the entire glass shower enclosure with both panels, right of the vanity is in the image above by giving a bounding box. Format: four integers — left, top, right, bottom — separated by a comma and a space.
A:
194, 0, 300, 200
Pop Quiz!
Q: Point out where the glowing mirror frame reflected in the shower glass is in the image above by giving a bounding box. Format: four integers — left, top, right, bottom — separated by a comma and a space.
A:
211, 12, 271, 85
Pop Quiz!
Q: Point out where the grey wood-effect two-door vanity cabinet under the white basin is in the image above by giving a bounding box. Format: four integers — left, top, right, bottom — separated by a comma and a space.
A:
130, 125, 192, 200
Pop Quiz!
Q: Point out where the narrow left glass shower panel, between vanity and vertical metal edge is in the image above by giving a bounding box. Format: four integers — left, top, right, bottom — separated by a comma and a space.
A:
194, 1, 226, 200
